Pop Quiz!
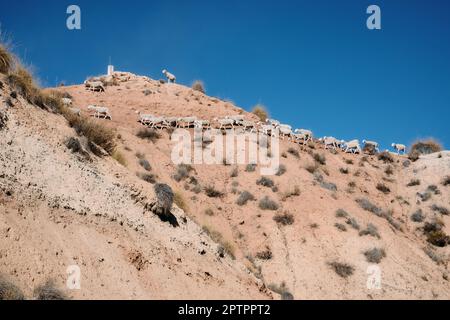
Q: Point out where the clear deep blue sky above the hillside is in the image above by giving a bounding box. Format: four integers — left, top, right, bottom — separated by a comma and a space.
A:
0, 0, 450, 148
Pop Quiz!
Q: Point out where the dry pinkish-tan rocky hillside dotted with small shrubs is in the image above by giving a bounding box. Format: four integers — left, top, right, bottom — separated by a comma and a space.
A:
0, 70, 450, 299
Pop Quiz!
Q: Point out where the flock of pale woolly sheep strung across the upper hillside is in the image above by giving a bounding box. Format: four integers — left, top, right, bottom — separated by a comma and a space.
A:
71, 70, 406, 154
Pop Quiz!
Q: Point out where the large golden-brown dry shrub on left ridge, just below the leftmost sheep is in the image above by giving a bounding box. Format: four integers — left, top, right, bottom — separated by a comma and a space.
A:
62, 108, 116, 154
